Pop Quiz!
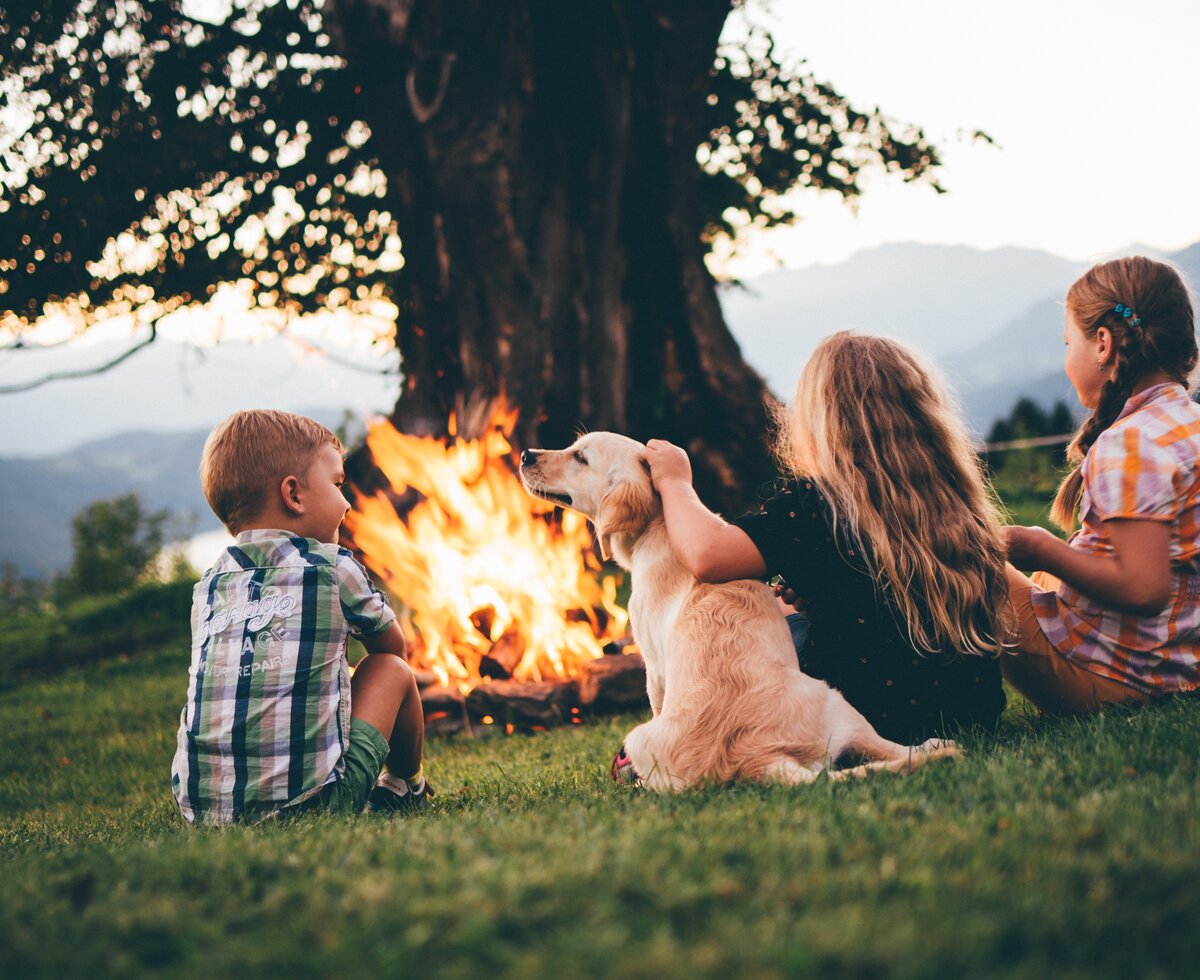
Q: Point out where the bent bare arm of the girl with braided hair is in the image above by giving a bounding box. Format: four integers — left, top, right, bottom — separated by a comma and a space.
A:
1004, 519, 1171, 617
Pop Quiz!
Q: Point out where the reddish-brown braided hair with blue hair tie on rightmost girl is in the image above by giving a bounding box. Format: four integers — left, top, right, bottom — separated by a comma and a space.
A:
1050, 255, 1196, 530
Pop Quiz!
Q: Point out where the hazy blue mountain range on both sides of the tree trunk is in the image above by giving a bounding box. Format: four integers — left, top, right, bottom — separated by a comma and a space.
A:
0, 236, 1200, 576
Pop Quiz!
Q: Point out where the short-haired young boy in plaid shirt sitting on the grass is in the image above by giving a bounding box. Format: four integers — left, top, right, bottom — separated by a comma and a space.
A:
172, 410, 433, 824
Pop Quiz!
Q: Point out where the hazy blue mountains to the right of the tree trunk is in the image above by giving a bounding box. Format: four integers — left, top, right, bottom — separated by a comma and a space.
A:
722, 242, 1200, 434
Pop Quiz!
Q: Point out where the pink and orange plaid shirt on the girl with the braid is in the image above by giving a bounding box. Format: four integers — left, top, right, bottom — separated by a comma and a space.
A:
1032, 384, 1200, 692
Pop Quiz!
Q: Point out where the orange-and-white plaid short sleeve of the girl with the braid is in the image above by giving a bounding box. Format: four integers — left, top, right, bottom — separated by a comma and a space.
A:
1084, 425, 1180, 521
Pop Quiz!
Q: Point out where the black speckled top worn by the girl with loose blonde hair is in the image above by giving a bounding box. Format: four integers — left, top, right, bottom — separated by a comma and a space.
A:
733, 480, 1004, 744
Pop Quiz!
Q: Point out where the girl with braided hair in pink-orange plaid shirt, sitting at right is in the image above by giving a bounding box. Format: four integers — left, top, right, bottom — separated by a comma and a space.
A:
1002, 257, 1200, 714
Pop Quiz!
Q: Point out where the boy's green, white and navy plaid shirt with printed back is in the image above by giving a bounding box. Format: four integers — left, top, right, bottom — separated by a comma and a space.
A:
172, 530, 396, 824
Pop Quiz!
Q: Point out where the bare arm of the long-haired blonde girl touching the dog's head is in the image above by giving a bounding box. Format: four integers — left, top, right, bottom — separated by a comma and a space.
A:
646, 439, 767, 582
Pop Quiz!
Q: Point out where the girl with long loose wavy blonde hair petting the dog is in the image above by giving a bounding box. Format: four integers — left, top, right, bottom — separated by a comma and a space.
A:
646, 332, 1007, 741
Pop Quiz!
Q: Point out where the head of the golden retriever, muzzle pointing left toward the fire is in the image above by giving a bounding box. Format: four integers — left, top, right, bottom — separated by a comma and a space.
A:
521, 432, 661, 558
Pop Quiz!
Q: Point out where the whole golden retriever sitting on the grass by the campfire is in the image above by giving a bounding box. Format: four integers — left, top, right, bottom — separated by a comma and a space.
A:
521, 432, 955, 790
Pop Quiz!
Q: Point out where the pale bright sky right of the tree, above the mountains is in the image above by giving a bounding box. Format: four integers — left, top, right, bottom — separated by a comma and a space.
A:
715, 0, 1200, 275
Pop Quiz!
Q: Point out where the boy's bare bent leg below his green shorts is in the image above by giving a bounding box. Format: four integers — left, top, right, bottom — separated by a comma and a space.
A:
350, 654, 425, 778
